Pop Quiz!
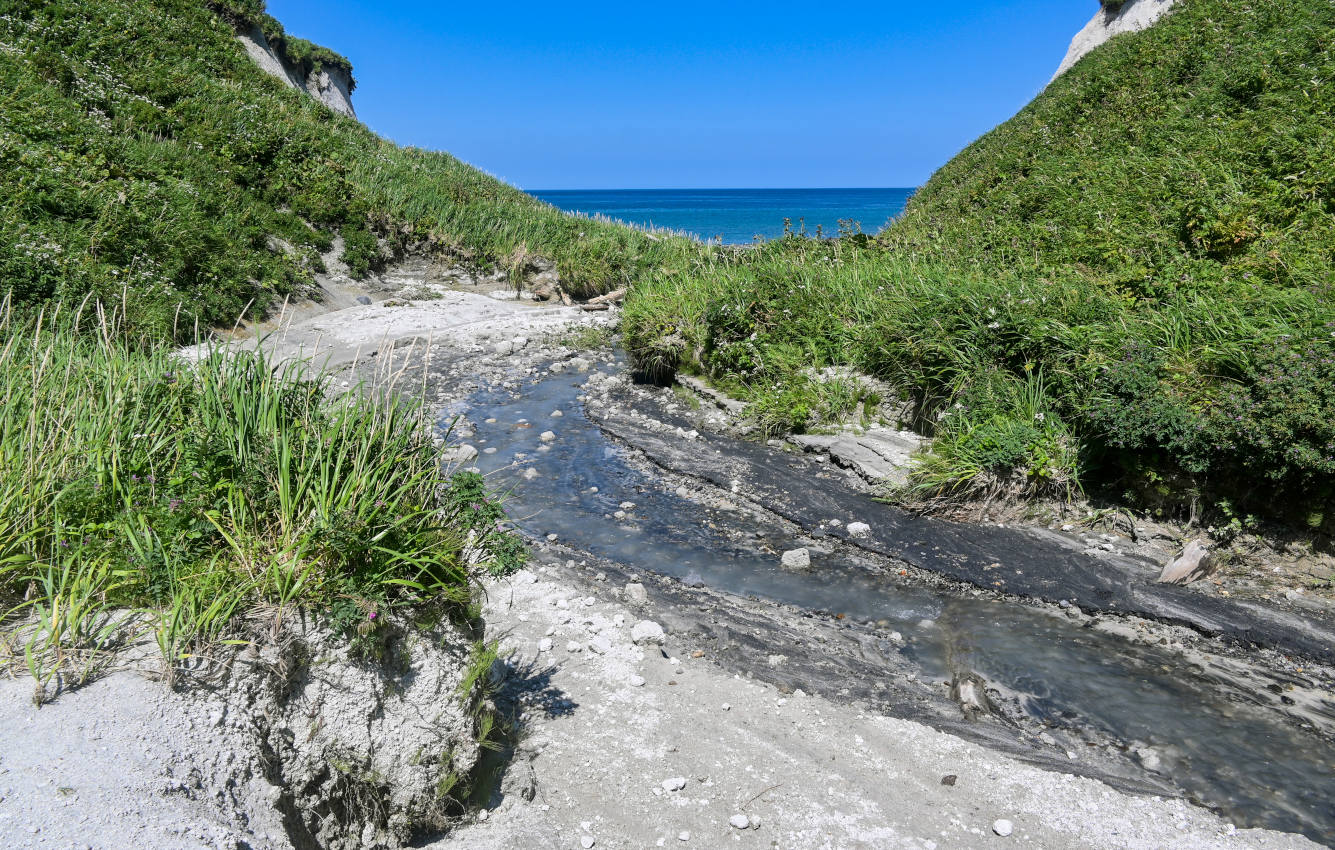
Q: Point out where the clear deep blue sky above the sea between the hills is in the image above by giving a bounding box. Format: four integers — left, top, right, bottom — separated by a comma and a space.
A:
268, 0, 1099, 189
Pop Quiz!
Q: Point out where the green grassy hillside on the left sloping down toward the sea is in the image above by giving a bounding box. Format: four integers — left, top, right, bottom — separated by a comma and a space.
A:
0, 0, 690, 338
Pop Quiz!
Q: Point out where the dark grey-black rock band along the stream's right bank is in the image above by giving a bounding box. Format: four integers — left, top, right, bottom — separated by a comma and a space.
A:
590, 391, 1335, 663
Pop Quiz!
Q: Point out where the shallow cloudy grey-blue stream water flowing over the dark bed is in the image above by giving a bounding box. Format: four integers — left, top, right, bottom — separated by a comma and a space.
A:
453, 365, 1335, 843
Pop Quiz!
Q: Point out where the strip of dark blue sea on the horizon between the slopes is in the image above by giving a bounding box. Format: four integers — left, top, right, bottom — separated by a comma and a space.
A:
529, 188, 913, 244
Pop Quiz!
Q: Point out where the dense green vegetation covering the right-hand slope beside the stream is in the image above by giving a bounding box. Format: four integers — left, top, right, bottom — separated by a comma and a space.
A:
625, 0, 1335, 531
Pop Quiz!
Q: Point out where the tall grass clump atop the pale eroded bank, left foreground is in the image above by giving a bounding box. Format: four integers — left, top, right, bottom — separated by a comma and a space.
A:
0, 304, 515, 682
